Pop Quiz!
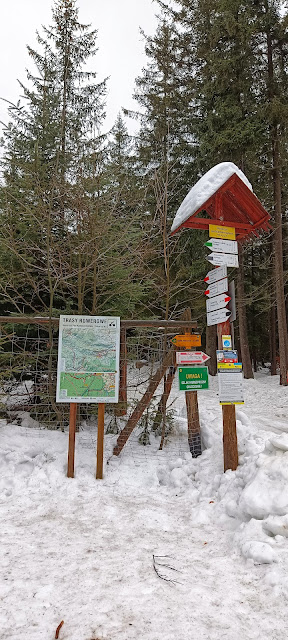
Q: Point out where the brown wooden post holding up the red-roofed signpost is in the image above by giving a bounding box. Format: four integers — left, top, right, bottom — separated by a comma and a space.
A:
217, 320, 238, 472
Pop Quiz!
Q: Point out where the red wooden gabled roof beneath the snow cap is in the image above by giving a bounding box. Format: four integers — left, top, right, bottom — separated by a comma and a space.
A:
171, 173, 271, 240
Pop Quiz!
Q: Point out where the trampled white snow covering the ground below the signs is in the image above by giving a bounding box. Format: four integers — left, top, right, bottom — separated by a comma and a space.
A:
0, 372, 288, 640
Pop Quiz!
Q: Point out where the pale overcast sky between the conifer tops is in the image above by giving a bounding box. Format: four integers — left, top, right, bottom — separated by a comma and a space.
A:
0, 0, 156, 133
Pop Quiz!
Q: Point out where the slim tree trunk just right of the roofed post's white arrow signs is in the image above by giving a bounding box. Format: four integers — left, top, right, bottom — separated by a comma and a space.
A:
237, 243, 254, 378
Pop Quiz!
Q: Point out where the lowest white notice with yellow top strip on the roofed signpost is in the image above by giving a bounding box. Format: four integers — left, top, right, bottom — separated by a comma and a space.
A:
218, 362, 244, 404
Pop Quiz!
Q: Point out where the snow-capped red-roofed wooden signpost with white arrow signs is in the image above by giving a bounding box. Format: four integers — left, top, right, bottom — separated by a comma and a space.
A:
171, 162, 270, 471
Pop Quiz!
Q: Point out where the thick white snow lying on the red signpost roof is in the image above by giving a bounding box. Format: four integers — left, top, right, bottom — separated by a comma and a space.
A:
171, 162, 253, 231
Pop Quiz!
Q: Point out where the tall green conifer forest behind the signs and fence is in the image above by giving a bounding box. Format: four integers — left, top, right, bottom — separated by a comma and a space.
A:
0, 0, 288, 385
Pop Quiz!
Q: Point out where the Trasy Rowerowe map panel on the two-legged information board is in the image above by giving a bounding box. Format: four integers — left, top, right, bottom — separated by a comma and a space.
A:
56, 316, 120, 403
